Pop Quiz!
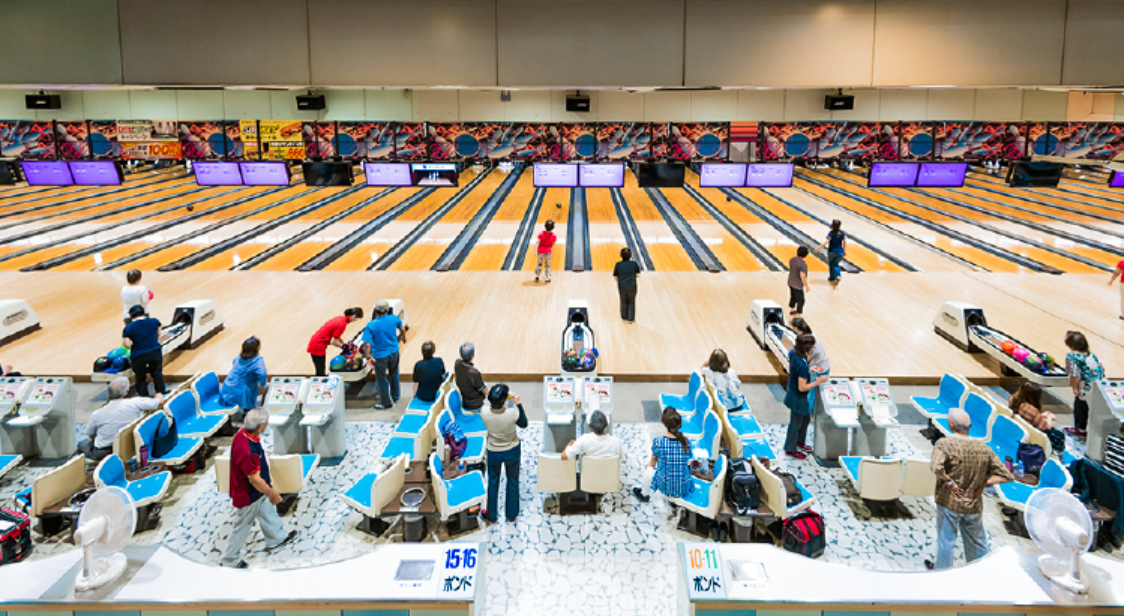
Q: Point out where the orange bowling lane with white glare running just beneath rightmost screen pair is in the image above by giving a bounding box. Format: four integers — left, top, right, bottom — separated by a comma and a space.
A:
808, 172, 1096, 273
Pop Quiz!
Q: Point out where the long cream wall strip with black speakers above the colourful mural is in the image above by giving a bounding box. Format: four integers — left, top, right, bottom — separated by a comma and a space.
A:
0, 88, 1124, 121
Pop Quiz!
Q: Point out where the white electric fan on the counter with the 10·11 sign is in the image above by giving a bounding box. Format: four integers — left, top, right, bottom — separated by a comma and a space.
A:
1025, 488, 1093, 595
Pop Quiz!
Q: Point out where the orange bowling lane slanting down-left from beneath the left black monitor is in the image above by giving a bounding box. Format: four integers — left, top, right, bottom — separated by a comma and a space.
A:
188, 188, 375, 270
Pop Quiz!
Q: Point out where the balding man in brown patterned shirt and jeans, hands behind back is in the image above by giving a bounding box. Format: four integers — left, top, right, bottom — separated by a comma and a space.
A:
925, 408, 1015, 569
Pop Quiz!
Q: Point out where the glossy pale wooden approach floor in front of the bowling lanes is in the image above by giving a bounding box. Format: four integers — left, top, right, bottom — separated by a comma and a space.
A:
0, 271, 1124, 382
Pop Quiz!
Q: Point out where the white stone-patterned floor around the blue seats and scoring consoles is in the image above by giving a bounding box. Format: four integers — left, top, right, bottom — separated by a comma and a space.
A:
0, 413, 1120, 616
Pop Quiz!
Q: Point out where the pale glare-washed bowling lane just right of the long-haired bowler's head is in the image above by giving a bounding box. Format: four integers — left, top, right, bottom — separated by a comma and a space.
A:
764, 183, 972, 272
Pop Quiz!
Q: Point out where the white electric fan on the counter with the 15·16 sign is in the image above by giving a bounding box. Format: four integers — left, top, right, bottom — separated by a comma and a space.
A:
74, 486, 137, 592
